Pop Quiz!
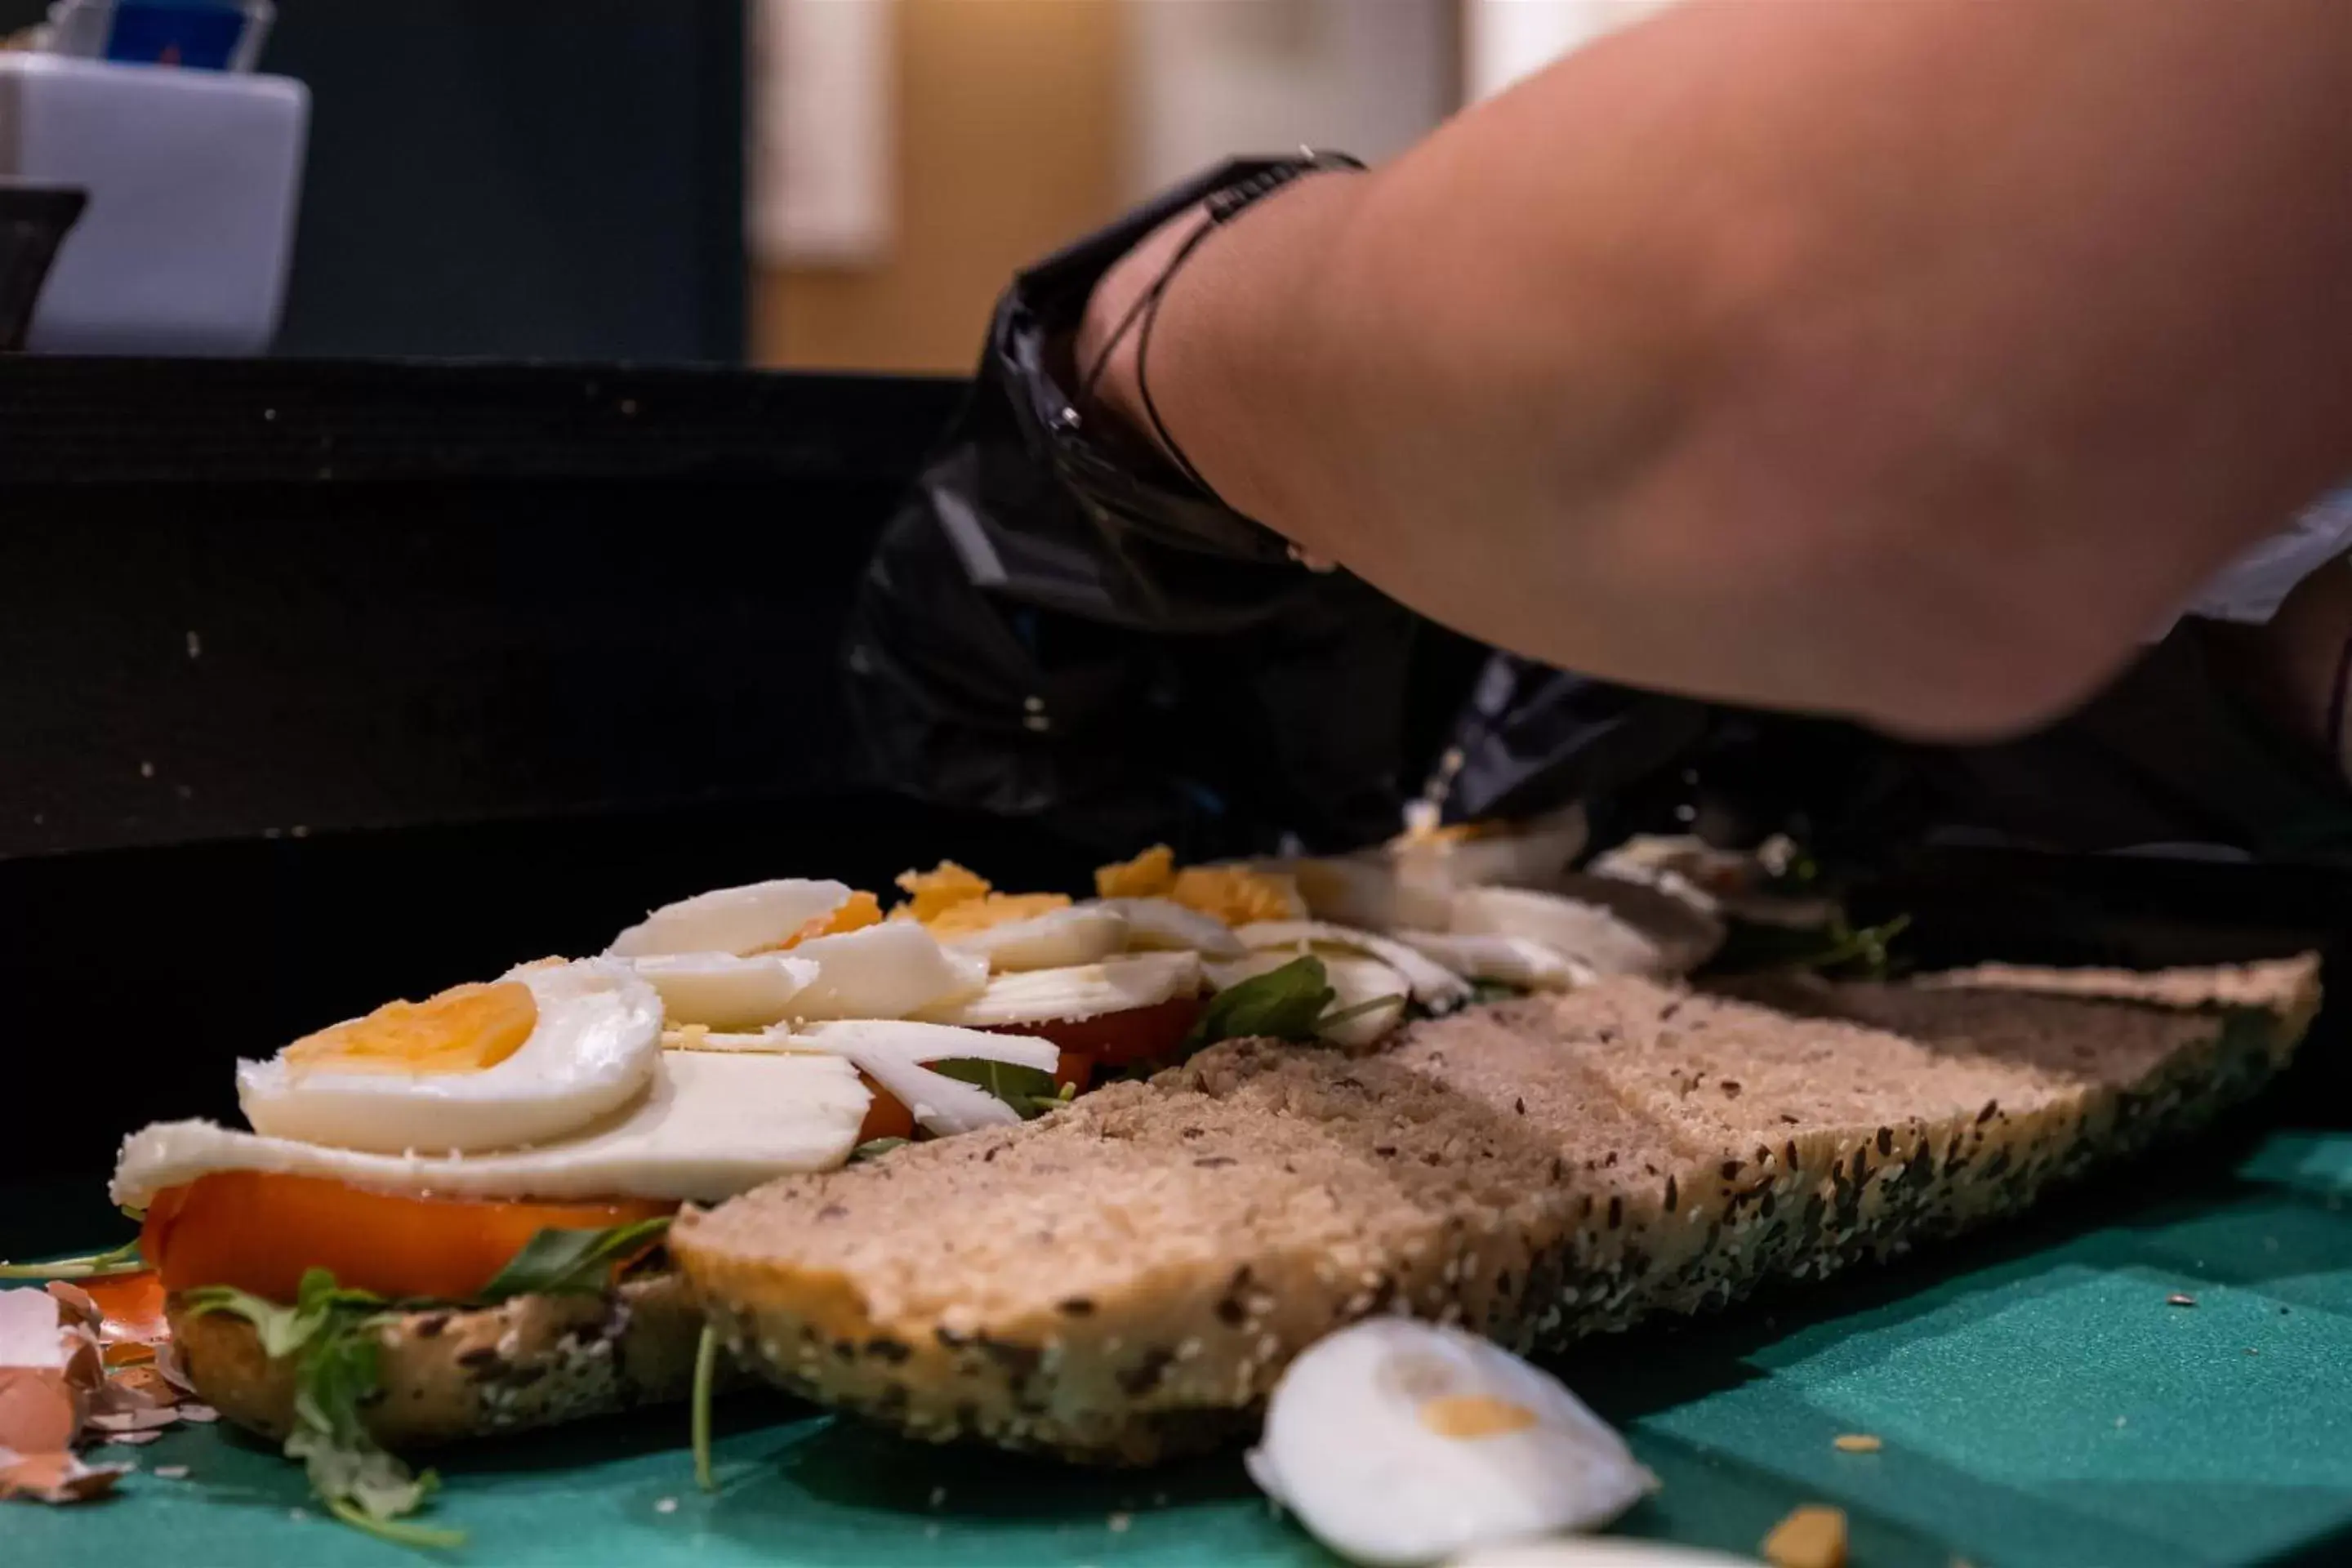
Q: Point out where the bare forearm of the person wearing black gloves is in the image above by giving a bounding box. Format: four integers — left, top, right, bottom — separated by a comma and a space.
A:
1077, 0, 2352, 733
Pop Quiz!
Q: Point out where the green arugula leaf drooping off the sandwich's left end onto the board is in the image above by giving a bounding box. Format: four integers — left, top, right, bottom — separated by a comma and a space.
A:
181, 1269, 466, 1547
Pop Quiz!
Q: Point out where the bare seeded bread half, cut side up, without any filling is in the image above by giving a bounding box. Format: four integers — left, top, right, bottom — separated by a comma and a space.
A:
670, 959, 2319, 1464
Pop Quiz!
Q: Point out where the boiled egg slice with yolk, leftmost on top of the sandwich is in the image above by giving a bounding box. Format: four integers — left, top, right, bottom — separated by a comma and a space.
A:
238, 959, 661, 1154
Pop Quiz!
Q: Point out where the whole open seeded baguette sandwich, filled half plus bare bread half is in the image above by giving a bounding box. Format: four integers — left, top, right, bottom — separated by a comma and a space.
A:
100, 832, 2317, 1544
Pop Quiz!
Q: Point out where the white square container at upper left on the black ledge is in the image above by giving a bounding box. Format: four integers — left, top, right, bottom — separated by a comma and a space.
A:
0, 54, 310, 355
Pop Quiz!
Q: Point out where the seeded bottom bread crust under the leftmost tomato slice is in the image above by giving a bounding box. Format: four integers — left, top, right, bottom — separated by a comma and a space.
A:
167, 1274, 703, 1448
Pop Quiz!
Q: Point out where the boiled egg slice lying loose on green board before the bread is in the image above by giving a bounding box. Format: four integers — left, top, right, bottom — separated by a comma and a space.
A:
1246, 1316, 1656, 1568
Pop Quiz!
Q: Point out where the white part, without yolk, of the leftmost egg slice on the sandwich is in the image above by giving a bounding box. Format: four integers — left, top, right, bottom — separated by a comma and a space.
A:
238, 959, 661, 1154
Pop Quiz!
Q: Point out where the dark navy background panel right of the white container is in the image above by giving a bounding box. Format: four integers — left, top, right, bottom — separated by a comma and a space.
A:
0, 0, 746, 364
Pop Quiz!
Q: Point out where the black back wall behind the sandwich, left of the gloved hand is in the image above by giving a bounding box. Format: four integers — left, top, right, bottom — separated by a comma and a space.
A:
0, 359, 973, 1175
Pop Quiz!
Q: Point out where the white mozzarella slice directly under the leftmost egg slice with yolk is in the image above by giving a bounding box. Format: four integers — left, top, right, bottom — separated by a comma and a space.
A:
113, 1051, 872, 1209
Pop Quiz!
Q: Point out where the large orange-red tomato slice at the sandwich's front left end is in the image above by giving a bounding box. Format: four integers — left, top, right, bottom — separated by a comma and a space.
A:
139, 1171, 677, 1303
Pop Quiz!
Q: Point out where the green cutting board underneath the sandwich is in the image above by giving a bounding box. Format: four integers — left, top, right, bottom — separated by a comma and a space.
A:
18, 1133, 2352, 1568
